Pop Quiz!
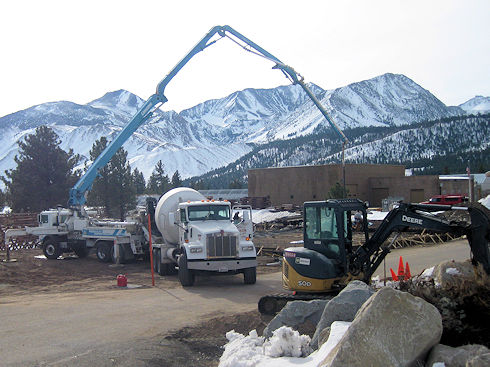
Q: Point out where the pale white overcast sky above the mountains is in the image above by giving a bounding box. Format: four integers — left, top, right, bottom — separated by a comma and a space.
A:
0, 0, 490, 117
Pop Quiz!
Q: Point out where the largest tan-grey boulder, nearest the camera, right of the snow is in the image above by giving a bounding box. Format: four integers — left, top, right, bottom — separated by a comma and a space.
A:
322, 287, 442, 367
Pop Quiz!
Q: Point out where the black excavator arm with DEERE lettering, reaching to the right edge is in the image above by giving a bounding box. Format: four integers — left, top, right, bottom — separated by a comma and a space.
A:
349, 203, 490, 280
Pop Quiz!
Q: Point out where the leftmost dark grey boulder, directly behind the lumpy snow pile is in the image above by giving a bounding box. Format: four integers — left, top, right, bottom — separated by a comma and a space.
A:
263, 300, 328, 338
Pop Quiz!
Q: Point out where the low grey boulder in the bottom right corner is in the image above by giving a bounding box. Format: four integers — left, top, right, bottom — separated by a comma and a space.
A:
426, 344, 490, 367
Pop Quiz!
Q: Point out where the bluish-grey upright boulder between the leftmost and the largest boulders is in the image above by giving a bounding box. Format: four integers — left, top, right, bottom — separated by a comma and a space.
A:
311, 280, 374, 349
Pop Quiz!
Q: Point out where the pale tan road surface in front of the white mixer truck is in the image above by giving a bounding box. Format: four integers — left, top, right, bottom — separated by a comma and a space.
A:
0, 273, 280, 366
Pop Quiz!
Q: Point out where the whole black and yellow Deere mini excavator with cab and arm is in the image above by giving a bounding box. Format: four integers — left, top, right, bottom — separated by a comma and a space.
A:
258, 199, 490, 314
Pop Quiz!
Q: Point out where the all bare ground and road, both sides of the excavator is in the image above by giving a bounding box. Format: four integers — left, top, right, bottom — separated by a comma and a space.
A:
0, 241, 469, 366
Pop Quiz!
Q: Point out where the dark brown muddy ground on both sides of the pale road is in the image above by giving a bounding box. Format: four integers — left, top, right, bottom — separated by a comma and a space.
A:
0, 239, 280, 366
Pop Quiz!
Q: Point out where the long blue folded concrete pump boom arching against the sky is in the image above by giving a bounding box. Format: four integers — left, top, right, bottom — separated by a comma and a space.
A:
68, 25, 348, 209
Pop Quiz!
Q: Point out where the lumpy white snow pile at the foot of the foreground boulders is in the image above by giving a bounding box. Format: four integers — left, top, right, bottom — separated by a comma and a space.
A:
219, 321, 350, 367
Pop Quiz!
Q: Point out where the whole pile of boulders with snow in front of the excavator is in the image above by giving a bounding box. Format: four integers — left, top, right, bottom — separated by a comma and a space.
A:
220, 263, 490, 367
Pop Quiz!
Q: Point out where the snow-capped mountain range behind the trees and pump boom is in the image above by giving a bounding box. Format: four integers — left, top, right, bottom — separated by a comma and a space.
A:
0, 74, 476, 187
